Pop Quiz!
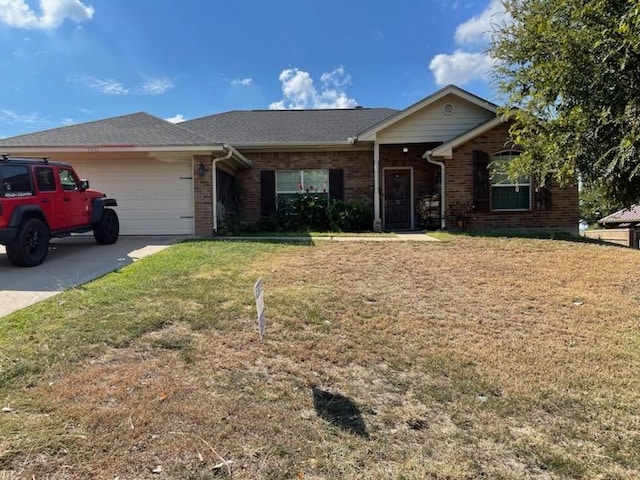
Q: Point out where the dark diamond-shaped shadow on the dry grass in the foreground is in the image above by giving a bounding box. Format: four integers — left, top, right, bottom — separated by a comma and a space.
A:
311, 387, 369, 438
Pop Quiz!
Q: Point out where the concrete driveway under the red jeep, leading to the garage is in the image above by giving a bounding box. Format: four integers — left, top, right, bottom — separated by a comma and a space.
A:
0, 235, 184, 317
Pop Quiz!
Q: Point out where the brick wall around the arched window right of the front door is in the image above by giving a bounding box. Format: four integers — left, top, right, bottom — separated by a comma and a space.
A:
444, 125, 579, 234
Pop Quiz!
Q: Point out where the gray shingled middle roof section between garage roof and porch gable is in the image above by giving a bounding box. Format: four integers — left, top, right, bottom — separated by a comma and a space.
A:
178, 108, 398, 147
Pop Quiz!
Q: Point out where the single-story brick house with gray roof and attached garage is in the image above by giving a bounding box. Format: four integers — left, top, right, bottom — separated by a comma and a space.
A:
0, 85, 578, 236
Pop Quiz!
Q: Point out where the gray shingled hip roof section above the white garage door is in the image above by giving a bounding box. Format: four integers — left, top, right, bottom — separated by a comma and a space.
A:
0, 112, 212, 149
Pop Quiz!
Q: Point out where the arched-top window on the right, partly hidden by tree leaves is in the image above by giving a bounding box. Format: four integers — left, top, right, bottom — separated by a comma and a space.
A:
491, 151, 531, 210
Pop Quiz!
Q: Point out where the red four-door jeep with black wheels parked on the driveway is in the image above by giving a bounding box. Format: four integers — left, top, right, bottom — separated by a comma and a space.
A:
0, 155, 120, 267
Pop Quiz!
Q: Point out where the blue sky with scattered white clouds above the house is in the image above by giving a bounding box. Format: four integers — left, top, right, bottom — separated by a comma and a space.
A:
0, 0, 508, 138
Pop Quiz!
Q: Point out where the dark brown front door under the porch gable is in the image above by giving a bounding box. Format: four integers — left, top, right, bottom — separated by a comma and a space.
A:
384, 169, 411, 230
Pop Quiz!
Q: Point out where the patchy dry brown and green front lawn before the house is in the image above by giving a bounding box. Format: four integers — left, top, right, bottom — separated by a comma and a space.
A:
0, 236, 640, 480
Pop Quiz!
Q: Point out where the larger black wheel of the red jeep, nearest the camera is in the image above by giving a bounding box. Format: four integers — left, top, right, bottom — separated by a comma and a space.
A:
6, 218, 49, 267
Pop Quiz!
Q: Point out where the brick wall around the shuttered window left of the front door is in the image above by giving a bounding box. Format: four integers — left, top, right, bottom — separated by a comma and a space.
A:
237, 150, 373, 222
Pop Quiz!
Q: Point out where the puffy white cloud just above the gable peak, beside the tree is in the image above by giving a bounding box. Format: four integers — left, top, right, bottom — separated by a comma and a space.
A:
429, 50, 493, 85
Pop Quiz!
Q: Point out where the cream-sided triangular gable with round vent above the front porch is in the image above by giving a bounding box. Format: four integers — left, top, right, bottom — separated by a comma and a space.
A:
377, 93, 496, 144
